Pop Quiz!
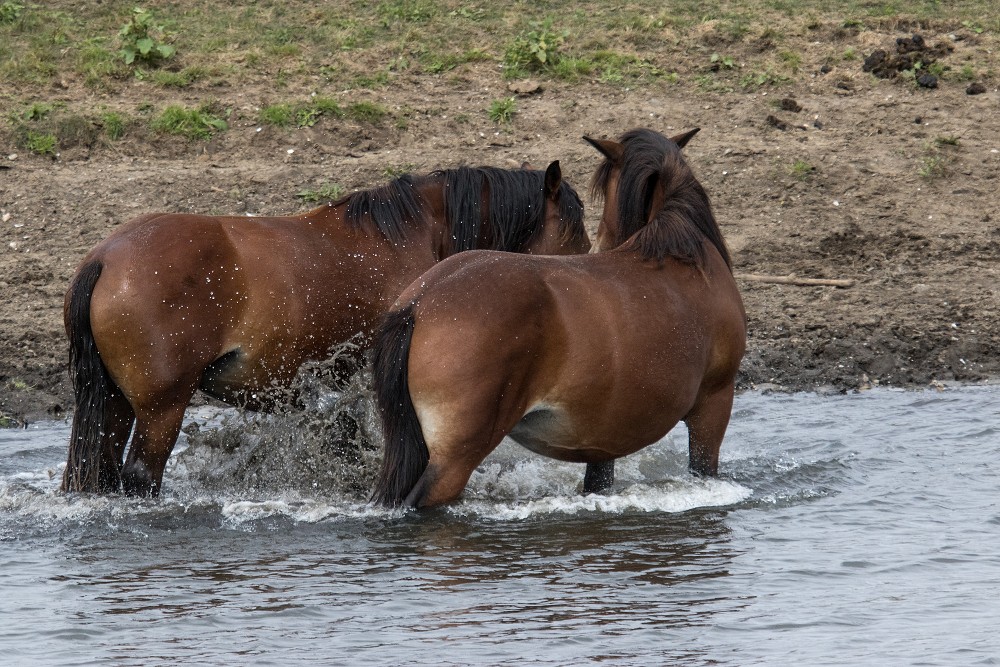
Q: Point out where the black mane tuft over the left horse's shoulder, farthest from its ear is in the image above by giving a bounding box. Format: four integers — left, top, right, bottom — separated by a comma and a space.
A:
342, 174, 427, 243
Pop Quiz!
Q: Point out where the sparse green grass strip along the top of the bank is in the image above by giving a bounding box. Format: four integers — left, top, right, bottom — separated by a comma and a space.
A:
0, 0, 1000, 150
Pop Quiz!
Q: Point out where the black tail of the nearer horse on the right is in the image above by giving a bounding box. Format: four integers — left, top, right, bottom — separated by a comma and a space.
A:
372, 304, 430, 507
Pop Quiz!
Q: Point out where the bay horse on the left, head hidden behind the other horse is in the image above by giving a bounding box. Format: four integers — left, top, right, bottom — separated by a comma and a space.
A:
62, 161, 590, 496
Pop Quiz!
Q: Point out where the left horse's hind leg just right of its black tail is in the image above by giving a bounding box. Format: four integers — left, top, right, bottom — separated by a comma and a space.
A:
122, 392, 193, 496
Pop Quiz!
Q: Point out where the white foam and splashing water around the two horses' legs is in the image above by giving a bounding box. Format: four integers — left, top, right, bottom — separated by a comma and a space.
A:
0, 418, 753, 534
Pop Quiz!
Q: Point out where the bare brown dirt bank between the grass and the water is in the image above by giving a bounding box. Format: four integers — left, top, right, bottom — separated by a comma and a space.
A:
0, 30, 1000, 421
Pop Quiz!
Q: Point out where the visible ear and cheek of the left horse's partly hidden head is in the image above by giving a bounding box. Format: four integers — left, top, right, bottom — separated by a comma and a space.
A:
525, 160, 590, 255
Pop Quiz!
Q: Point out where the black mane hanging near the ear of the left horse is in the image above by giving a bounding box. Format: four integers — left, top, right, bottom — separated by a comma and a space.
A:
432, 167, 586, 252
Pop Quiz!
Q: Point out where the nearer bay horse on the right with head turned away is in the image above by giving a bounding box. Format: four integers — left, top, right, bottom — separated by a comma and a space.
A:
372, 129, 746, 507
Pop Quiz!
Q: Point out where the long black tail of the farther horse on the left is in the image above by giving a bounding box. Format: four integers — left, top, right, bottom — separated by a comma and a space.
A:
62, 262, 123, 493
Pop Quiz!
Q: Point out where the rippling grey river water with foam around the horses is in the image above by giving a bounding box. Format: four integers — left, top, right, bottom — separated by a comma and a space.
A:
0, 387, 1000, 666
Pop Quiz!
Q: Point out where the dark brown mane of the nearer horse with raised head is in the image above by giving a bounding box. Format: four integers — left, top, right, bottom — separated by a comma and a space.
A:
591, 128, 733, 270
